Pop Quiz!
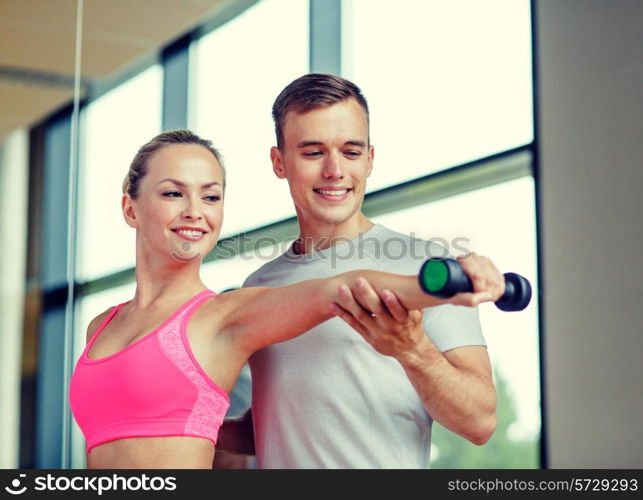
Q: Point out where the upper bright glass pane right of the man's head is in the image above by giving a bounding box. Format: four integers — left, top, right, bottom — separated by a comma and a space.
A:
342, 0, 533, 190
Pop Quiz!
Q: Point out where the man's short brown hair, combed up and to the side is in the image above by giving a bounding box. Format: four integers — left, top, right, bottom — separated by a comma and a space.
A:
272, 73, 369, 148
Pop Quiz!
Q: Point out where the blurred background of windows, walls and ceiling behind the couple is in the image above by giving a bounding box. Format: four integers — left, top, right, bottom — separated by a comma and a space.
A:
0, 0, 643, 468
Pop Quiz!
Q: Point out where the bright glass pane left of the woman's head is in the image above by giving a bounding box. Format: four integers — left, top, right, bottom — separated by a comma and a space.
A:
78, 66, 163, 280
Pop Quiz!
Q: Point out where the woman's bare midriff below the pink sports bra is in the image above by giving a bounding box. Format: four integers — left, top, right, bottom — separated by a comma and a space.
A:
87, 436, 214, 469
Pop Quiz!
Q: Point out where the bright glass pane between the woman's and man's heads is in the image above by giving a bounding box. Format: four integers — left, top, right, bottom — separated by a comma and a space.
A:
191, 0, 308, 236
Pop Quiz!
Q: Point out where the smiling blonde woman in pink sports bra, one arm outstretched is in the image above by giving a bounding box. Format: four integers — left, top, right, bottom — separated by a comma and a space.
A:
70, 131, 502, 468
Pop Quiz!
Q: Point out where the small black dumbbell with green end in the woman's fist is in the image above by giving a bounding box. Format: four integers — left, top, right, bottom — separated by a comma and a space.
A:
419, 258, 531, 311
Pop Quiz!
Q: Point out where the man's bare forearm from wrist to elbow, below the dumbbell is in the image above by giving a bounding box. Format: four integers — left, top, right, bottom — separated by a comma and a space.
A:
398, 337, 496, 445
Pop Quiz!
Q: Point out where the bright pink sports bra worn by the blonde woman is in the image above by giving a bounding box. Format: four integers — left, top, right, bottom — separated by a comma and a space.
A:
69, 290, 230, 453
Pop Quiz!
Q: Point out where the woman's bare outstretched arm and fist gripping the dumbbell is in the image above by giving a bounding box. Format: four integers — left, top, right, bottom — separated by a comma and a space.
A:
225, 256, 504, 354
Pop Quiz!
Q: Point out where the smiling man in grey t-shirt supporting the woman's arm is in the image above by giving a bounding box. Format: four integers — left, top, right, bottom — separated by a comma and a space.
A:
219, 74, 504, 468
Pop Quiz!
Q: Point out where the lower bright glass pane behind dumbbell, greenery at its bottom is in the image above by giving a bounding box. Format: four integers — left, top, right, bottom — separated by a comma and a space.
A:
376, 177, 541, 468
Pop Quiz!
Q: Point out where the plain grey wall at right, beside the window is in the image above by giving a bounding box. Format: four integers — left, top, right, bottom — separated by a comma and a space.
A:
536, 0, 643, 468
